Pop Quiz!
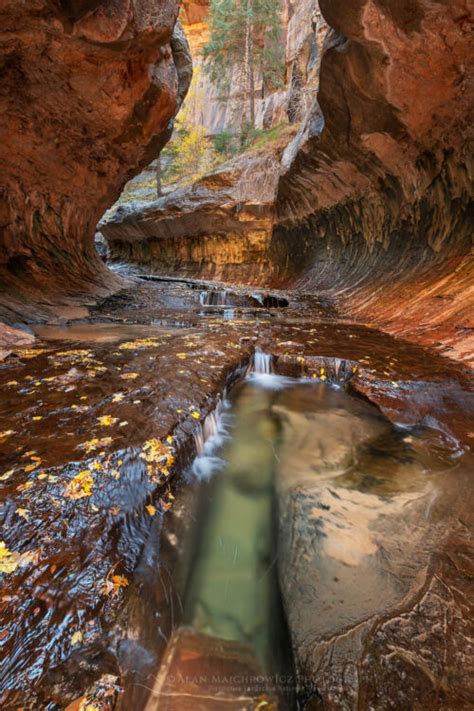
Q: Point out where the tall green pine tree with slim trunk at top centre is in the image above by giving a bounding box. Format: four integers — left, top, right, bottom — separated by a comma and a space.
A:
203, 0, 284, 128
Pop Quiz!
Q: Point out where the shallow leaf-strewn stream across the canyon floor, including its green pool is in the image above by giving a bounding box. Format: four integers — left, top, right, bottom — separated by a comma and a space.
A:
0, 282, 472, 711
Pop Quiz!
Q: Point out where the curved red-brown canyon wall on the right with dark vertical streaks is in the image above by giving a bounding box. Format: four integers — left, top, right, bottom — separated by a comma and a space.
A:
272, 0, 474, 360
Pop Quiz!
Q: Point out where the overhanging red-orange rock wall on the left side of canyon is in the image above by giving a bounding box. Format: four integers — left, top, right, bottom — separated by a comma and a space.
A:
0, 0, 191, 323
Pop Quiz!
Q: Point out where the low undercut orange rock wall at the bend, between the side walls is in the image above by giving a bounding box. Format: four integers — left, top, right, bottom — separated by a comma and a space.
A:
101, 151, 279, 284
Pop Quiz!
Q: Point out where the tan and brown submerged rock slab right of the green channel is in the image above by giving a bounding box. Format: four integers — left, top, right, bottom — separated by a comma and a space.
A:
273, 382, 470, 709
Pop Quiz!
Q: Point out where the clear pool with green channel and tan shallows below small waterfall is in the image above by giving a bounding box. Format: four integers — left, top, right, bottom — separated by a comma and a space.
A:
120, 364, 468, 711
